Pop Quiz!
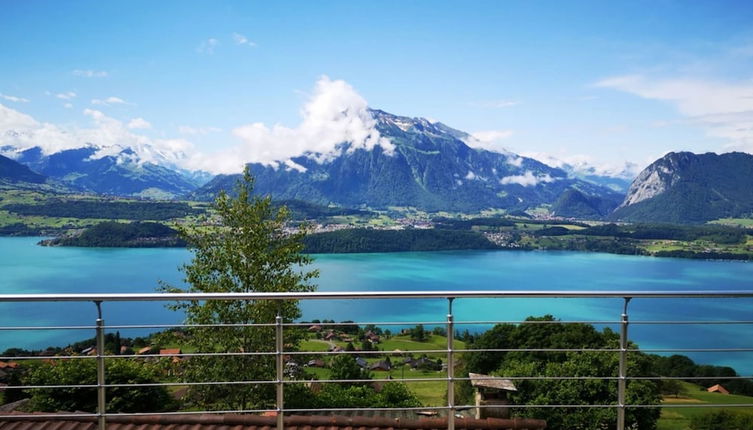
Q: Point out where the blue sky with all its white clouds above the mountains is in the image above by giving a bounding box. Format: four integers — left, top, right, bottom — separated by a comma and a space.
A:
0, 0, 753, 173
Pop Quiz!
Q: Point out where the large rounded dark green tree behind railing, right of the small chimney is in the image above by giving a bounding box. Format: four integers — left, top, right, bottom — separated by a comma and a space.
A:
459, 315, 660, 430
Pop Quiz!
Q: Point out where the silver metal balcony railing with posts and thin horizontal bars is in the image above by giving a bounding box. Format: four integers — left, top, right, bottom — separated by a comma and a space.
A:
0, 291, 753, 430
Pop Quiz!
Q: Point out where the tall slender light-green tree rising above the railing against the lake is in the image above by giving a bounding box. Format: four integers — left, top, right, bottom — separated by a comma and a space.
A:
163, 169, 319, 410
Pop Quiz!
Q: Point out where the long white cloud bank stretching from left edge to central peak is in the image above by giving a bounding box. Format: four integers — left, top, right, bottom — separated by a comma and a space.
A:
0, 76, 394, 173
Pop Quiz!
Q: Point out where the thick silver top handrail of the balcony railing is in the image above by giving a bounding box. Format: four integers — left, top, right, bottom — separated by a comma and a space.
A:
0, 290, 753, 302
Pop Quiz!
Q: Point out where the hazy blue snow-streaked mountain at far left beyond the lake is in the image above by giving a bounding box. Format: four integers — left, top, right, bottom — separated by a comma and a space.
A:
16, 146, 196, 198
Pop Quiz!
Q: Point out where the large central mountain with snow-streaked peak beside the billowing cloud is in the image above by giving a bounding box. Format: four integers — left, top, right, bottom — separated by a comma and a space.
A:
194, 110, 621, 211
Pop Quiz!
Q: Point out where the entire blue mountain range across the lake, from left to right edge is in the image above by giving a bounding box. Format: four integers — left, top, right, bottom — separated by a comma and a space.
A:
0, 110, 753, 223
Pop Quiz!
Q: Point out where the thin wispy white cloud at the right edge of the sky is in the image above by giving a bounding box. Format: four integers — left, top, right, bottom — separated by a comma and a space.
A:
594, 75, 753, 152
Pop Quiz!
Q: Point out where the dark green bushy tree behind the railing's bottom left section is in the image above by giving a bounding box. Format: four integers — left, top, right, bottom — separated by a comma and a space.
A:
22, 358, 173, 412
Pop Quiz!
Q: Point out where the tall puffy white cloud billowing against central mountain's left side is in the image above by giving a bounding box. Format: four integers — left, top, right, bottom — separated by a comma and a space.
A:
192, 76, 394, 173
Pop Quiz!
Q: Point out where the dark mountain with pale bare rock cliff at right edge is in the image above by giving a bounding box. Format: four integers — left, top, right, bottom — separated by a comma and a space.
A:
611, 152, 753, 223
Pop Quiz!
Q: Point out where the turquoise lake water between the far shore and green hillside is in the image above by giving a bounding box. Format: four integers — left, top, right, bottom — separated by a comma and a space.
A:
0, 237, 753, 375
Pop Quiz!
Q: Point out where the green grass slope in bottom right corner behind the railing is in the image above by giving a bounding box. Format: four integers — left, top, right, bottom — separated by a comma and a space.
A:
657, 382, 753, 430
